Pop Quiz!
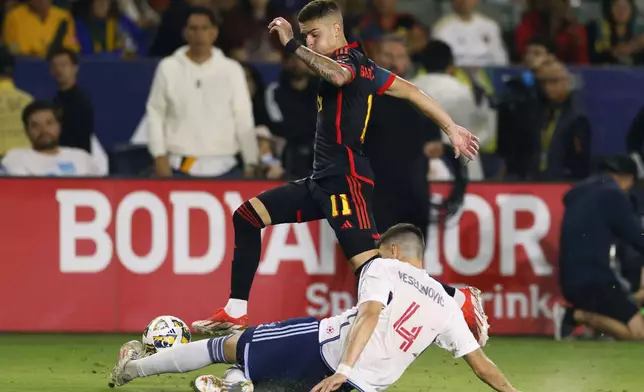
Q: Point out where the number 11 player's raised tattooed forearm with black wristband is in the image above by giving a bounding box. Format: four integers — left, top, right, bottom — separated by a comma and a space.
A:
268, 18, 353, 87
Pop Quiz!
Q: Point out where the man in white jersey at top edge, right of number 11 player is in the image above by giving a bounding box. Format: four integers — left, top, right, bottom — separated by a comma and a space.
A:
432, 0, 508, 67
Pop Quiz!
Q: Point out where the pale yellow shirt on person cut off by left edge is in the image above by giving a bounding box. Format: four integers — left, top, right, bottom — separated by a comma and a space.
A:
0, 79, 33, 156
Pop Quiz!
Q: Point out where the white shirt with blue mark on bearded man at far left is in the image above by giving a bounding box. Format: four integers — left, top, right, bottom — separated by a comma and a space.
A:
2, 147, 105, 177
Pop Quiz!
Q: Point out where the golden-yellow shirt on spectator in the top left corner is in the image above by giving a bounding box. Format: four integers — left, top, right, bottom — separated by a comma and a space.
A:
2, 4, 78, 58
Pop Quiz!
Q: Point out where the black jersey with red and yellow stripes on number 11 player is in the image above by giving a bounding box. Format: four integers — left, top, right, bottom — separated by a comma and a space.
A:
313, 43, 396, 184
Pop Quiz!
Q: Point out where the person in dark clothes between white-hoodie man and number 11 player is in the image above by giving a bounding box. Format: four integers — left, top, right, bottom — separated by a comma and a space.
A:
266, 55, 318, 179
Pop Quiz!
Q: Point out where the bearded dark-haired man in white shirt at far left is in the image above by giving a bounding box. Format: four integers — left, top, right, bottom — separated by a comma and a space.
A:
2, 101, 105, 177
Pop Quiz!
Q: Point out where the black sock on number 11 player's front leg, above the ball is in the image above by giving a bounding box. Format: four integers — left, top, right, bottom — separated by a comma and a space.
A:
230, 201, 264, 301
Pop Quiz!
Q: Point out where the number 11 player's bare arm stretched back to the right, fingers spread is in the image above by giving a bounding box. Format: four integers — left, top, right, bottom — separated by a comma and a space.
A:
385, 76, 480, 160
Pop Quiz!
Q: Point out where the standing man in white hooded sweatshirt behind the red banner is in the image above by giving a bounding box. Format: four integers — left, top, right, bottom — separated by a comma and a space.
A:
147, 7, 259, 179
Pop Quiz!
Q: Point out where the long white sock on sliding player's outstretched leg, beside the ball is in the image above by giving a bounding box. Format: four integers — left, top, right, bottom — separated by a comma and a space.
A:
125, 339, 212, 378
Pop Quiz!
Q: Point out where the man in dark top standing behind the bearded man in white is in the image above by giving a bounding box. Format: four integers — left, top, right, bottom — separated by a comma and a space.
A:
49, 49, 94, 152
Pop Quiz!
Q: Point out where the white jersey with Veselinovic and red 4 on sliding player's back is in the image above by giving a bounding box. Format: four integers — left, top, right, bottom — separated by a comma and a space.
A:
320, 259, 479, 391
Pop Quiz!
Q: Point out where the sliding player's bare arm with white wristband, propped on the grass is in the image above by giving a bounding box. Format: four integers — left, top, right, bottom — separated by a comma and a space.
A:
311, 301, 383, 392
